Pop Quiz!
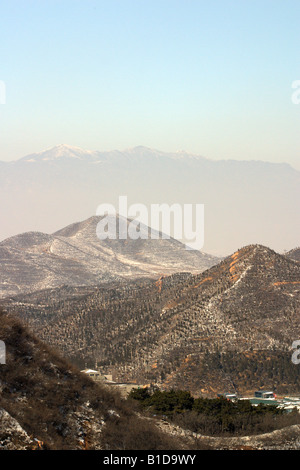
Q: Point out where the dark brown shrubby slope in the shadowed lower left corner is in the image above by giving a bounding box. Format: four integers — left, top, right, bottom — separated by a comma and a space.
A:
0, 311, 185, 450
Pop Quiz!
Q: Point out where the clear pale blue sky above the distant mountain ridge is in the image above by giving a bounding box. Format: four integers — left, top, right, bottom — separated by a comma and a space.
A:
0, 0, 300, 170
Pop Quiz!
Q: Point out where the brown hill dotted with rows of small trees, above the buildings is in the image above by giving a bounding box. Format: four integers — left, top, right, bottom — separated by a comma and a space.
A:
8, 245, 300, 396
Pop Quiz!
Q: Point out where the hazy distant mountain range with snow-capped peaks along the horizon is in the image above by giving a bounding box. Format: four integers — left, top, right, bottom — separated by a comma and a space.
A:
0, 145, 300, 256
